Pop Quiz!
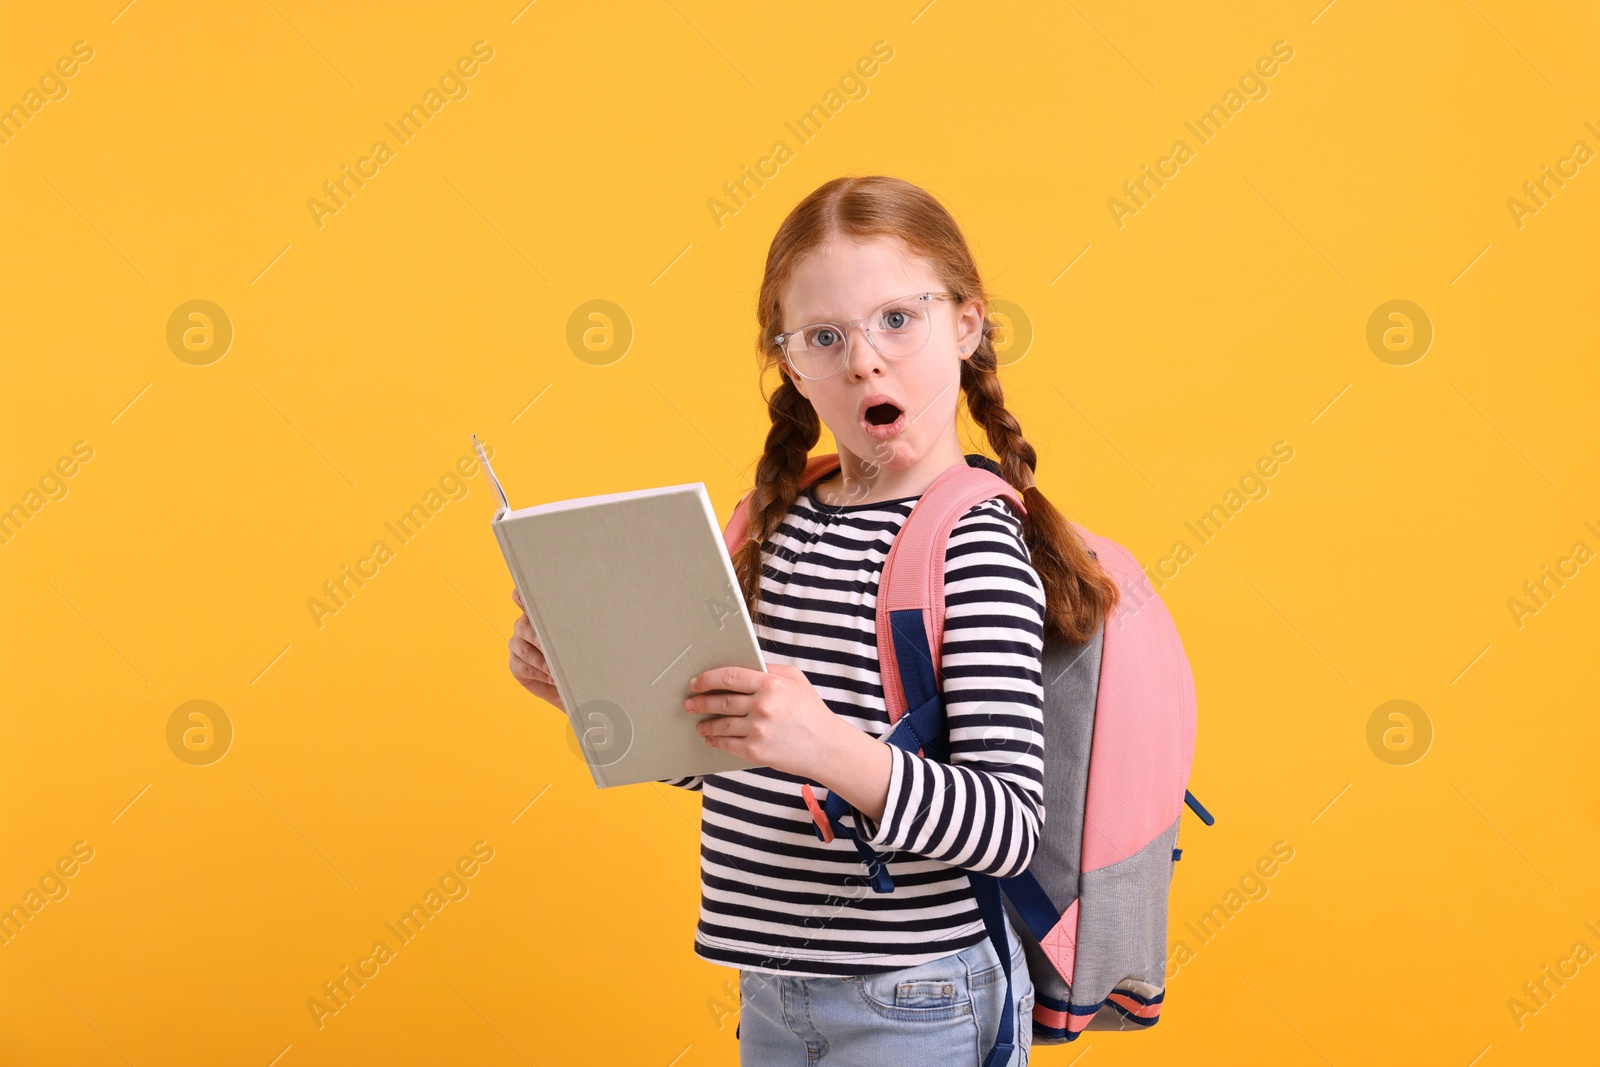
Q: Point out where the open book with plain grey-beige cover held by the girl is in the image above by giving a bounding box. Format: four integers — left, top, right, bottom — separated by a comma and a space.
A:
472, 434, 766, 789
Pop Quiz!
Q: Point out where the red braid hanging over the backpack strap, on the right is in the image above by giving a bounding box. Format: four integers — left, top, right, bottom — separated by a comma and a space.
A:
962, 334, 1117, 643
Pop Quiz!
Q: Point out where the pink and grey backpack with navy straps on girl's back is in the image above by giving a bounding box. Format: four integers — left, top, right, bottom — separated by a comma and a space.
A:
723, 454, 1213, 1067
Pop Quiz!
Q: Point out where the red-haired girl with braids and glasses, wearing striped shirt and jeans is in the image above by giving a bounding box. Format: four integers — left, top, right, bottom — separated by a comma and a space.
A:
510, 178, 1115, 1067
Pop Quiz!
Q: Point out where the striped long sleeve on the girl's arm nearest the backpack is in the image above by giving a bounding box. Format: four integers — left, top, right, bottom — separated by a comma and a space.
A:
859, 498, 1045, 878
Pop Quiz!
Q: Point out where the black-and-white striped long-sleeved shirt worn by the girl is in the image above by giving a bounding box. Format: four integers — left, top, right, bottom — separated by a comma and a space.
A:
662, 488, 1045, 977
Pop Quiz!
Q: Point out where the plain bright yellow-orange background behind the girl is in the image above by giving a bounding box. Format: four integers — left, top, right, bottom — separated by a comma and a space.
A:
0, 0, 1600, 1067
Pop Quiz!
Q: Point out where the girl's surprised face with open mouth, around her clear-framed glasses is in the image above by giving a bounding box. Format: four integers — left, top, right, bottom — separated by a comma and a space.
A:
779, 237, 982, 494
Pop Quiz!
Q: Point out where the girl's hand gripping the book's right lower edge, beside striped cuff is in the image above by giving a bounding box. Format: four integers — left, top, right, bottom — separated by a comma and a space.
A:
683, 664, 853, 777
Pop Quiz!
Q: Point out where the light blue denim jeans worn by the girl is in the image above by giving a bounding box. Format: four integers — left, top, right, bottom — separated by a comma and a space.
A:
739, 923, 1034, 1067
